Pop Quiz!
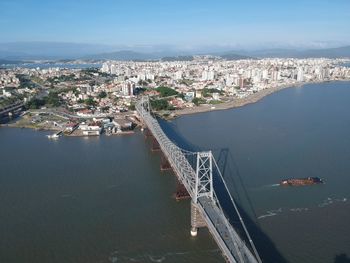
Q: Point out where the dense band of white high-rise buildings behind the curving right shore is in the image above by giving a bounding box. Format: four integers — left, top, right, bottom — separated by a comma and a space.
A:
101, 57, 350, 100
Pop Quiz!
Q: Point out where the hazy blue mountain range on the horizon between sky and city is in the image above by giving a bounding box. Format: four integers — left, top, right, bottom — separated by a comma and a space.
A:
0, 42, 350, 62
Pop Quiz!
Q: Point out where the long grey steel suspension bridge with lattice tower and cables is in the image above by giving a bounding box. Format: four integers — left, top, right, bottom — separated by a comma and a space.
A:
136, 97, 262, 263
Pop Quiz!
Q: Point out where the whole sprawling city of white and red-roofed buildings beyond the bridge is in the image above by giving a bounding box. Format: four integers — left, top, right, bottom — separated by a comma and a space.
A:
0, 56, 350, 132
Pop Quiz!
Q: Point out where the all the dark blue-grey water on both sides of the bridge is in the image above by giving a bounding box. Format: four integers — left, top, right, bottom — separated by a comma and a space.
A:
0, 82, 350, 263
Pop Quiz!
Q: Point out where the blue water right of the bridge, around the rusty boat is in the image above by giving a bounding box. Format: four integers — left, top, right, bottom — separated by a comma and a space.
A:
162, 82, 350, 263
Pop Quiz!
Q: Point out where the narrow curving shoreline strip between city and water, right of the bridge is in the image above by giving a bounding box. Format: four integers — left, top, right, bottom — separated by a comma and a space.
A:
167, 79, 350, 120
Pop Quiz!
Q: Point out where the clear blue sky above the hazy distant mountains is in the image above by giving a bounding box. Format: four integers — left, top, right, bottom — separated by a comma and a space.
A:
0, 0, 350, 48
